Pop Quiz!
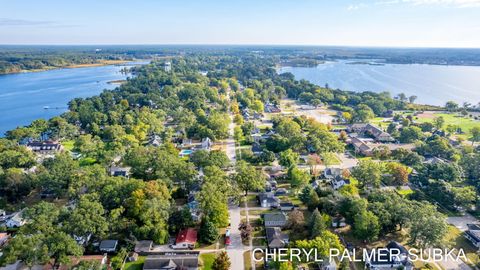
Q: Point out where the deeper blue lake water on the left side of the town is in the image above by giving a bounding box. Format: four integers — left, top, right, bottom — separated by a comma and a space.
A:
0, 63, 144, 137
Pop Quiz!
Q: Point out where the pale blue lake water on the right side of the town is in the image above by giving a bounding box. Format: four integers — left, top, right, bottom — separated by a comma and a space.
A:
279, 60, 480, 105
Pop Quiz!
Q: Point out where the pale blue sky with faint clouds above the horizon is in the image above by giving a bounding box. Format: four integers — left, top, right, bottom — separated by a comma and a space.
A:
0, 0, 480, 48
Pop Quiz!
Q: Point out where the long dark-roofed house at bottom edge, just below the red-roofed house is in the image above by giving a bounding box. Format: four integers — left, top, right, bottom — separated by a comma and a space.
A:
143, 252, 200, 270
